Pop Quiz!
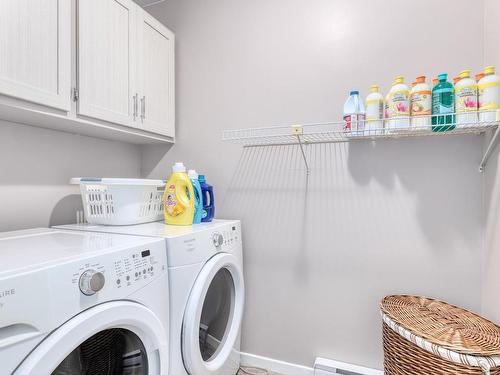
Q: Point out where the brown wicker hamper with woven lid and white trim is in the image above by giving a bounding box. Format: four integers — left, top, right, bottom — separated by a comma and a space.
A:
380, 296, 500, 375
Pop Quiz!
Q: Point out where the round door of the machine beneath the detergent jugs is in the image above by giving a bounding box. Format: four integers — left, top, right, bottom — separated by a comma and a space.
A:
182, 253, 245, 375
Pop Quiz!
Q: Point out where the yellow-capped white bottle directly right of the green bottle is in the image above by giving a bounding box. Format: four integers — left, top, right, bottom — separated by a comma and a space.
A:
455, 70, 477, 128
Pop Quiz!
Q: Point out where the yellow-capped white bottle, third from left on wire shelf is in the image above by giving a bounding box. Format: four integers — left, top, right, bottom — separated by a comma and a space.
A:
385, 76, 410, 134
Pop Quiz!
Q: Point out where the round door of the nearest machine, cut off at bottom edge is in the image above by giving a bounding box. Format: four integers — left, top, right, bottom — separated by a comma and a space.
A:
14, 301, 168, 375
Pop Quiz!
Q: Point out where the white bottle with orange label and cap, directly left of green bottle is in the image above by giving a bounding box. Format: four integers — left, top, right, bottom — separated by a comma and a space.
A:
410, 76, 432, 131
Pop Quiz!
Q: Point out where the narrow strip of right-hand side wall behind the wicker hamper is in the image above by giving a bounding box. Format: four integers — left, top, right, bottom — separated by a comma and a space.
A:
482, 0, 500, 322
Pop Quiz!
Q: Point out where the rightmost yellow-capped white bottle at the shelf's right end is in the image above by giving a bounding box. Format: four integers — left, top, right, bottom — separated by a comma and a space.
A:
477, 66, 500, 122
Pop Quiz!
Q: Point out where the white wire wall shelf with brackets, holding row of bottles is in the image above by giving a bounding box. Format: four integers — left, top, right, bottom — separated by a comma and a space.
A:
222, 110, 500, 172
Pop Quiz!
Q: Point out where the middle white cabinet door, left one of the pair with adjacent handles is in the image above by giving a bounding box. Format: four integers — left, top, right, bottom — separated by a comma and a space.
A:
78, 0, 138, 126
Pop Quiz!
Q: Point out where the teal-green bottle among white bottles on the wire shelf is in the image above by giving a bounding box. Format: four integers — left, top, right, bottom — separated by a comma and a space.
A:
432, 73, 455, 132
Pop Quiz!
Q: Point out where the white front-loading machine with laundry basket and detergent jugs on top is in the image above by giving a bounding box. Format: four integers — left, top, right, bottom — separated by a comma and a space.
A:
60, 220, 245, 375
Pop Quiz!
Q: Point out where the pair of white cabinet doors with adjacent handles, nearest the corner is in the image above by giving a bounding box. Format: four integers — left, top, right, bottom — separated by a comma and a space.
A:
77, 0, 175, 138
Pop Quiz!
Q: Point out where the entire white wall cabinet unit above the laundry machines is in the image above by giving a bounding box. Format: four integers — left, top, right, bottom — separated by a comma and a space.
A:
0, 0, 175, 143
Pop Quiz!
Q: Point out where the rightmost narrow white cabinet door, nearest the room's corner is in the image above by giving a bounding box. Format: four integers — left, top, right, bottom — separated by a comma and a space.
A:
138, 9, 175, 137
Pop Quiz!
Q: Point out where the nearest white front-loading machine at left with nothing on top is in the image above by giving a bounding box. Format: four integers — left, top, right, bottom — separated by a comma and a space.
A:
0, 229, 169, 375
